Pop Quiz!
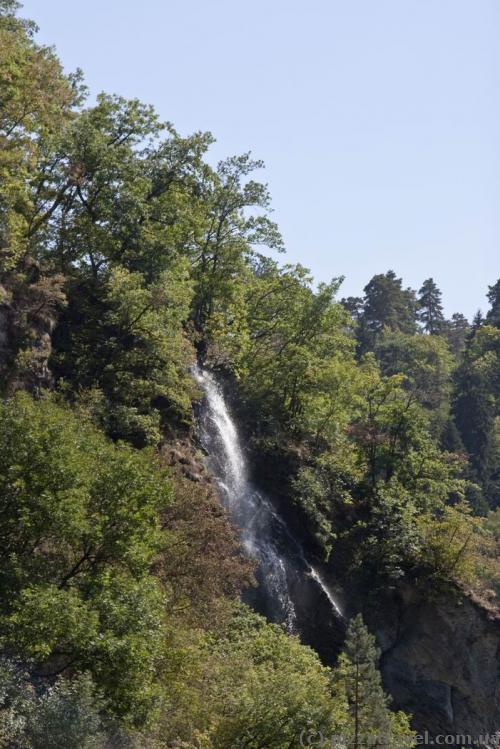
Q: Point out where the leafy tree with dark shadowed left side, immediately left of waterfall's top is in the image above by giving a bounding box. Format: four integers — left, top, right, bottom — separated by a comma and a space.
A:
53, 260, 194, 446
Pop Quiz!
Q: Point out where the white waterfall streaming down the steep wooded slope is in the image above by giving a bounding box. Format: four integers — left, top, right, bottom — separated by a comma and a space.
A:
193, 367, 343, 632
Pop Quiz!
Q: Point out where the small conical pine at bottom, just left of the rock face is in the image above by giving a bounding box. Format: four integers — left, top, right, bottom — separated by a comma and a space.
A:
337, 614, 393, 748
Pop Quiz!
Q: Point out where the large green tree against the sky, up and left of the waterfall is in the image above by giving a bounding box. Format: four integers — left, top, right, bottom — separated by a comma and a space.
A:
44, 94, 211, 280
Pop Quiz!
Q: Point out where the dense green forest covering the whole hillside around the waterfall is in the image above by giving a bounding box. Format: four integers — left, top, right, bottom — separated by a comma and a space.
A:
0, 0, 500, 749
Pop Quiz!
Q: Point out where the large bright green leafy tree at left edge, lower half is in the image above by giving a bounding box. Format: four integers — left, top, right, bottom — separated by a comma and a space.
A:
0, 395, 171, 716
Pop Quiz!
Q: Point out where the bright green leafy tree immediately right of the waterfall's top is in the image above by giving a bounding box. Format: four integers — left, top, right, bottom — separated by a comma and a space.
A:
241, 261, 355, 439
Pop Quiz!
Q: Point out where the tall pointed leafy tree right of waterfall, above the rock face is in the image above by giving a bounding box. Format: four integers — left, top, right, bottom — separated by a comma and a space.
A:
332, 357, 466, 580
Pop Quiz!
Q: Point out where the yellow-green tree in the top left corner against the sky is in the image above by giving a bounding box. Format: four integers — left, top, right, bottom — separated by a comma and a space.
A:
0, 3, 76, 274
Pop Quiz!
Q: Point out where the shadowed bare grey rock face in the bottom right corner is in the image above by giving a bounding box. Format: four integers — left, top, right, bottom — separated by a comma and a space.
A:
367, 586, 500, 737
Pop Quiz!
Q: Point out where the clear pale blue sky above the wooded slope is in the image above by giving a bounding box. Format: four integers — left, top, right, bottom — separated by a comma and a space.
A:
24, 0, 500, 317
